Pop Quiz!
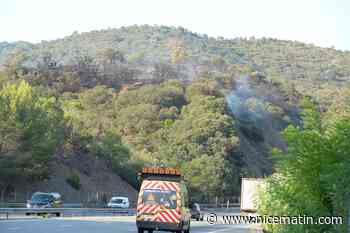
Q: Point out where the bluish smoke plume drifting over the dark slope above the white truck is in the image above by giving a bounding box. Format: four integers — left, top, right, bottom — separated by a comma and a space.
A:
226, 76, 298, 177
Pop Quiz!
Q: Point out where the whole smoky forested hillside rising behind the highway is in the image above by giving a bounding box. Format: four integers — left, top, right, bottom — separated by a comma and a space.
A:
0, 26, 350, 213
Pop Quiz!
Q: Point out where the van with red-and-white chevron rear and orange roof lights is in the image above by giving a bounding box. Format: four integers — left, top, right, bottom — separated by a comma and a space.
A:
136, 167, 191, 233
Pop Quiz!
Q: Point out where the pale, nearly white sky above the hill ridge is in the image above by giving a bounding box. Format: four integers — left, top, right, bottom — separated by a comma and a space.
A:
0, 0, 350, 51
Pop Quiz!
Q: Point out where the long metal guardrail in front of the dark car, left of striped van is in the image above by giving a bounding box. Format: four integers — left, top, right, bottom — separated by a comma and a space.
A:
0, 208, 136, 219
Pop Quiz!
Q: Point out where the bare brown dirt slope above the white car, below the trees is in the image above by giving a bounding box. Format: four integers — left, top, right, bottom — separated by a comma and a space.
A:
10, 154, 137, 205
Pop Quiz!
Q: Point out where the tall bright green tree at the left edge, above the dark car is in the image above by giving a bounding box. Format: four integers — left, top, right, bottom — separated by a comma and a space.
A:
0, 81, 64, 179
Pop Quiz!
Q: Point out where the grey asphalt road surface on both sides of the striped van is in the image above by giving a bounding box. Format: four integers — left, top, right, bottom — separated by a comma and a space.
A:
0, 217, 260, 233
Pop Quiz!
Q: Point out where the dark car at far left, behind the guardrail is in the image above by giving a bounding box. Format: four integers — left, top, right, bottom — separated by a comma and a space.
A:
27, 192, 62, 208
